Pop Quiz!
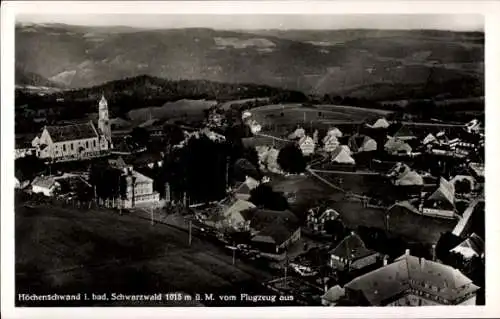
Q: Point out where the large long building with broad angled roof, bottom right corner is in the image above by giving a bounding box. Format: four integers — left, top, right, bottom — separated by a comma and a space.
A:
344, 250, 479, 307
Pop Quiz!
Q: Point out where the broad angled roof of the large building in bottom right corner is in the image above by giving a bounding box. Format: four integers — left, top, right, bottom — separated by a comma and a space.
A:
345, 255, 479, 306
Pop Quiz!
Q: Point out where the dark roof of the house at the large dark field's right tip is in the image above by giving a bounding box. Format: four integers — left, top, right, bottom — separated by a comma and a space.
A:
241, 209, 299, 245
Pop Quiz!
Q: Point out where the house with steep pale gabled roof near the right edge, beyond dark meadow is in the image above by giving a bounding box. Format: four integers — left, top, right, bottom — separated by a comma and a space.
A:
421, 177, 456, 218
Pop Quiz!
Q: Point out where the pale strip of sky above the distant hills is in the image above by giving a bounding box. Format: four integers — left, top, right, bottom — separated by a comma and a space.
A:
16, 14, 484, 31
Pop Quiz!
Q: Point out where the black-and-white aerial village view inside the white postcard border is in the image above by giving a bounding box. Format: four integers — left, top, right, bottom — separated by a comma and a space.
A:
12, 14, 487, 307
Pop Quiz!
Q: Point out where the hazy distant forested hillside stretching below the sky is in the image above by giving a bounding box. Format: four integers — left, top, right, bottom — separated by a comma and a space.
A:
16, 24, 484, 100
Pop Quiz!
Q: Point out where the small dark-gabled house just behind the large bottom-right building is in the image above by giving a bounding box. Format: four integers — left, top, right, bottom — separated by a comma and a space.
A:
329, 232, 380, 271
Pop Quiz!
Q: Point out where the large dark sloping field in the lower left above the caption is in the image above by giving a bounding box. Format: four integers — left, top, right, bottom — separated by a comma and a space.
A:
15, 204, 269, 305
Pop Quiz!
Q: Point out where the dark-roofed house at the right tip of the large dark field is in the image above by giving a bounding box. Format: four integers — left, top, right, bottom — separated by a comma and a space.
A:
241, 209, 301, 254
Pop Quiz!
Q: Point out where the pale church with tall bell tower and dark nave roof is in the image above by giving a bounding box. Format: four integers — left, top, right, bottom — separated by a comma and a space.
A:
32, 96, 113, 161
